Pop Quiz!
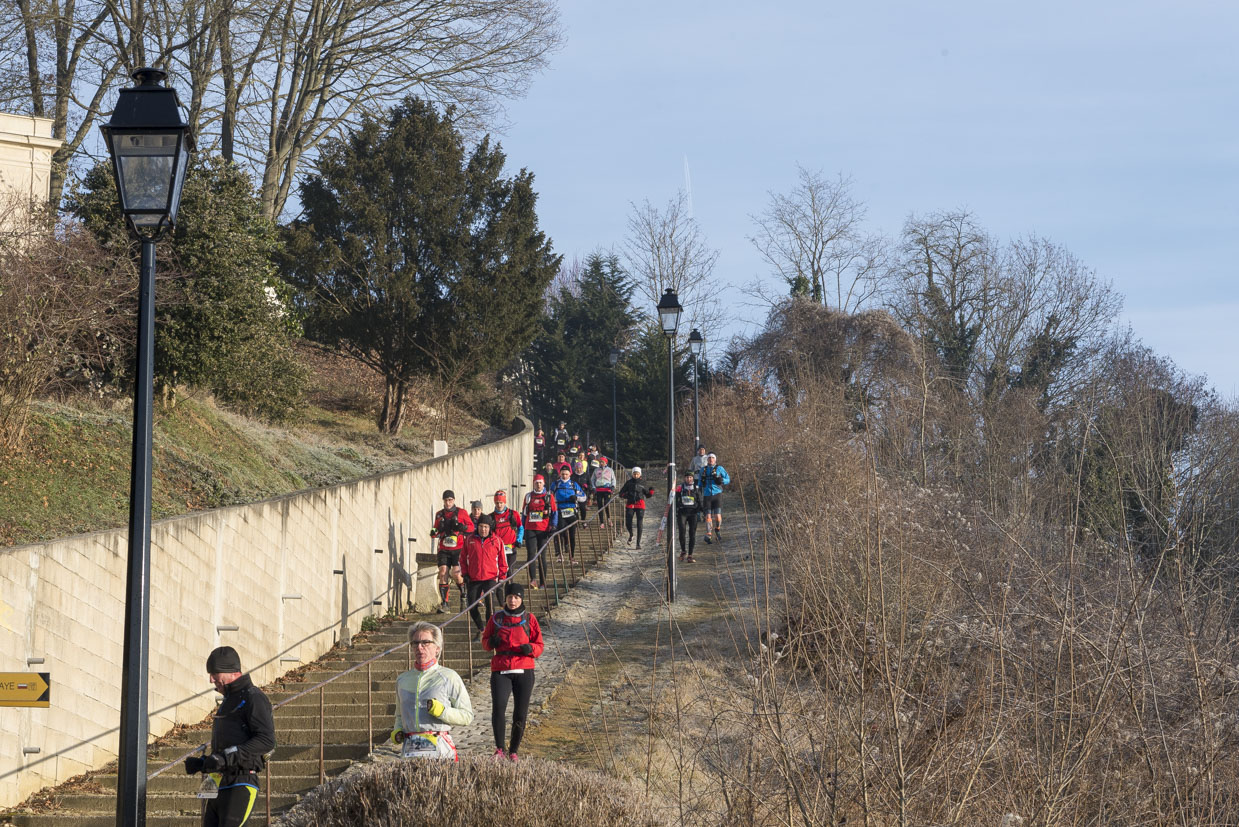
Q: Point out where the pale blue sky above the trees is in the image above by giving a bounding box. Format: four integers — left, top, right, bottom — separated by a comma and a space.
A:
498, 0, 1239, 398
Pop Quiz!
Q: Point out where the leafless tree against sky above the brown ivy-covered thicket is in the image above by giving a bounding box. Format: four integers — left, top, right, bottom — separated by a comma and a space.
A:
748, 165, 887, 312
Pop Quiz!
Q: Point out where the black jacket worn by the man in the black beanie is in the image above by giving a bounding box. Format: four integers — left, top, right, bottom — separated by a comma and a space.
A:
211, 674, 275, 787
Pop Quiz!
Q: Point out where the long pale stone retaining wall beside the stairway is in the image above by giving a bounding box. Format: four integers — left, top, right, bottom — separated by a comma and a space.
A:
0, 419, 533, 807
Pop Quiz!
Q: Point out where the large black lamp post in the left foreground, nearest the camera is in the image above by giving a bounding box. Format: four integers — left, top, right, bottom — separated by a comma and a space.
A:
100, 68, 193, 827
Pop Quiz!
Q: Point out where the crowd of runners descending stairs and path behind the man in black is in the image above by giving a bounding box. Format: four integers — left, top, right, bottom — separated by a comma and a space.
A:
408, 423, 731, 761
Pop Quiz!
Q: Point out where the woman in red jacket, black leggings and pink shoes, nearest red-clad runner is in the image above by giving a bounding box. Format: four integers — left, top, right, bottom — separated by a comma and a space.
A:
482, 580, 543, 761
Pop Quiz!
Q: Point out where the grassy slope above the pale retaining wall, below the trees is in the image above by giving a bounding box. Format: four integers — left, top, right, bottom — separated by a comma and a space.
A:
0, 352, 496, 547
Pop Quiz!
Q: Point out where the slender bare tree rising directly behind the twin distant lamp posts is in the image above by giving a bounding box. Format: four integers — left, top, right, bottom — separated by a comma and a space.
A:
623, 191, 722, 337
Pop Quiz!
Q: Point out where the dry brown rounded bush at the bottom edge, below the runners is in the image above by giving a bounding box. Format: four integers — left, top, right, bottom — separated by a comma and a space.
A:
281, 758, 665, 827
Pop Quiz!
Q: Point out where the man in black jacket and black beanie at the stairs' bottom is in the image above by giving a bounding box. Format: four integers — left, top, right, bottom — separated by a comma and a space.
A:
185, 646, 275, 827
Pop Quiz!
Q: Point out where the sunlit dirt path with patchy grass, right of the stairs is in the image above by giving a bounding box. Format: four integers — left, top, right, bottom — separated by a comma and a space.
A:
522, 497, 768, 774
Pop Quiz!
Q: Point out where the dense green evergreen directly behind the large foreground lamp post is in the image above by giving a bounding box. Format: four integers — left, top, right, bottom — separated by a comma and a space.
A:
68, 156, 305, 419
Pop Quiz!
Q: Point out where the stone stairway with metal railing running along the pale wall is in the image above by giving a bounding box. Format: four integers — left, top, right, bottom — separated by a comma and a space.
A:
0, 520, 616, 827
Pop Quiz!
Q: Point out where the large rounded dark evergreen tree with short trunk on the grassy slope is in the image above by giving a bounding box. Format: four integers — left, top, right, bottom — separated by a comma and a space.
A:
286, 98, 559, 434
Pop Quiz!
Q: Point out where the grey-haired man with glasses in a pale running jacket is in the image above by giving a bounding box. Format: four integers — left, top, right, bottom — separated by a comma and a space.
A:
392, 621, 473, 761
